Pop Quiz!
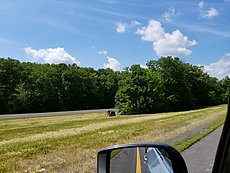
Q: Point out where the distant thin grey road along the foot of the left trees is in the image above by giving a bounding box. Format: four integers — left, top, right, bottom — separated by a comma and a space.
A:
0, 109, 117, 119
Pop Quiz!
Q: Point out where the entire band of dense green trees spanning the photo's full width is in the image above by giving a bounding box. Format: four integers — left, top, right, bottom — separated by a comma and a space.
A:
0, 57, 230, 114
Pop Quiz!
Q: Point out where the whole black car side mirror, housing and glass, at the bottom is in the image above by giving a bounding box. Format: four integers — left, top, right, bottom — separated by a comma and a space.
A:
97, 143, 188, 173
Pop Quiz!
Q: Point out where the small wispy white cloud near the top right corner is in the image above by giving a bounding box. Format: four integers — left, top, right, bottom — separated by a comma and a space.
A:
198, 1, 218, 19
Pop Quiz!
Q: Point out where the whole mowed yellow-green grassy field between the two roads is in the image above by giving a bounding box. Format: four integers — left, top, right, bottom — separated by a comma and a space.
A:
0, 105, 226, 172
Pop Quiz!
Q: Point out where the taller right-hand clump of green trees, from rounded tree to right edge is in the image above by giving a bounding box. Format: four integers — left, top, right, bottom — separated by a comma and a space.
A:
116, 56, 230, 114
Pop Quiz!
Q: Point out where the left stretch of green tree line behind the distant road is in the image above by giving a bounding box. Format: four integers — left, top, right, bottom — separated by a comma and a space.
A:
0, 58, 118, 114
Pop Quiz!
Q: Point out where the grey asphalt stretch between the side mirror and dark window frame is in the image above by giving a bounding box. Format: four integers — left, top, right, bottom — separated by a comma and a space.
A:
182, 126, 223, 173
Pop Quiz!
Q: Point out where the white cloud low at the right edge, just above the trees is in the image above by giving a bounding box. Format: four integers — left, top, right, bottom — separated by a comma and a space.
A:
204, 53, 230, 79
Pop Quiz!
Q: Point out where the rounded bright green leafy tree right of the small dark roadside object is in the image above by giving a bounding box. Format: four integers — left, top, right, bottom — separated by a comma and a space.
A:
115, 65, 162, 114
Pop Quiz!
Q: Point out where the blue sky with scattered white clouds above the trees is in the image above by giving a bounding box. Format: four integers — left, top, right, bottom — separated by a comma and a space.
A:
0, 0, 230, 79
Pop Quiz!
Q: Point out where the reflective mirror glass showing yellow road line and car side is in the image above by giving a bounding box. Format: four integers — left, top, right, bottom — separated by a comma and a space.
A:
110, 147, 173, 173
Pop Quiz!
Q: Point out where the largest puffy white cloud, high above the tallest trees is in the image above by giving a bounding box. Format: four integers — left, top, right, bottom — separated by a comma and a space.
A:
136, 20, 197, 57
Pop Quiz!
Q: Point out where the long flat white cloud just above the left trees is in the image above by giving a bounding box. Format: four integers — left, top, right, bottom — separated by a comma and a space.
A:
24, 47, 80, 65
